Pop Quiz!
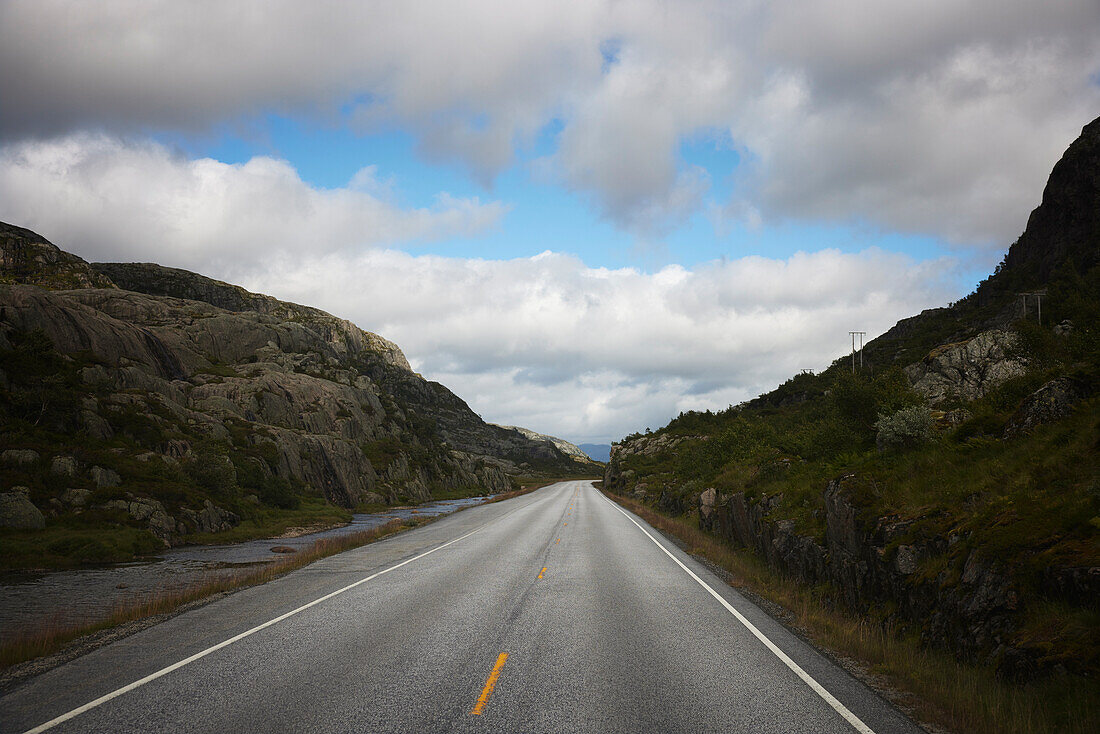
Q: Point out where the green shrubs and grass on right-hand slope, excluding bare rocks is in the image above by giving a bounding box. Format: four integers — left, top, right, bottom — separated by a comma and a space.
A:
607, 267, 1100, 732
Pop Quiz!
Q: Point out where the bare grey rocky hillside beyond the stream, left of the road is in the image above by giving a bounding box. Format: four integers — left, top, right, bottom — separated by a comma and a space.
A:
0, 224, 584, 557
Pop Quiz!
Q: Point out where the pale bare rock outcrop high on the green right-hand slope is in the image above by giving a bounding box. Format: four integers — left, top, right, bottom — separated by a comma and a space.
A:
904, 329, 1026, 405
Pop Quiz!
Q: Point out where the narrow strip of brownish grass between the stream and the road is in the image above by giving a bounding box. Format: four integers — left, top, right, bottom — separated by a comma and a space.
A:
0, 519, 418, 670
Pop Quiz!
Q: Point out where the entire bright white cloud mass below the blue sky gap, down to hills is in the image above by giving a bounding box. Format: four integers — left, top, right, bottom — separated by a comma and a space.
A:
0, 135, 955, 441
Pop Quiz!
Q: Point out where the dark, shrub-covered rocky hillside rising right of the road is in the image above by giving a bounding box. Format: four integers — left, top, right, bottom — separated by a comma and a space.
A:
605, 120, 1100, 679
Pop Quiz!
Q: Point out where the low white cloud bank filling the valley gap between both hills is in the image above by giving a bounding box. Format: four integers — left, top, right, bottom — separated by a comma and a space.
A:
244, 250, 954, 441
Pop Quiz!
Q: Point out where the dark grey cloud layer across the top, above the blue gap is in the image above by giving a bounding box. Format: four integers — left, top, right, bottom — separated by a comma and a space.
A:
0, 0, 1100, 248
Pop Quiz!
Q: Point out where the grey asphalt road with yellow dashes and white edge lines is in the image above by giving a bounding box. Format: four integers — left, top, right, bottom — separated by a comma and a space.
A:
0, 482, 921, 734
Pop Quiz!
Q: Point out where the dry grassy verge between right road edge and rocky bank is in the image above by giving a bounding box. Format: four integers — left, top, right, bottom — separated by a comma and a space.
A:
605, 492, 1100, 734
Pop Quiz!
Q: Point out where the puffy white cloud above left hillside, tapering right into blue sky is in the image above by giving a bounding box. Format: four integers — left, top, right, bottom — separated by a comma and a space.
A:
0, 134, 507, 274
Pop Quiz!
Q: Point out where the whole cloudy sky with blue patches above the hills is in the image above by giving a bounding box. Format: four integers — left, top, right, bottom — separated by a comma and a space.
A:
0, 0, 1100, 442
